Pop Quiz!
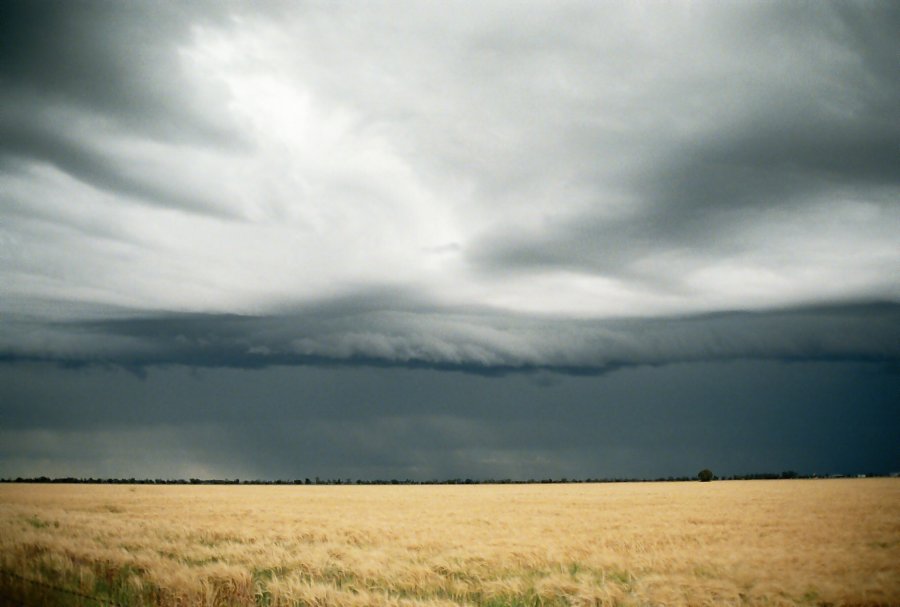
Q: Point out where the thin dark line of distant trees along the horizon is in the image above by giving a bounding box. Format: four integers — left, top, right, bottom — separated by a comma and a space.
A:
0, 470, 893, 485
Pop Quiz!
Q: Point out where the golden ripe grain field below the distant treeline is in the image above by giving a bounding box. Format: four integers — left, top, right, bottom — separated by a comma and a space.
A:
0, 479, 900, 607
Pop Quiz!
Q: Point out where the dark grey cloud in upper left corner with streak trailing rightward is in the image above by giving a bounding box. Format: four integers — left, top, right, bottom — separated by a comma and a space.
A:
0, 1, 239, 214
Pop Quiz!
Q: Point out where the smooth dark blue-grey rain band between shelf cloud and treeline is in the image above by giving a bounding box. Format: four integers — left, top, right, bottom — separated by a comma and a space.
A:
0, 361, 900, 480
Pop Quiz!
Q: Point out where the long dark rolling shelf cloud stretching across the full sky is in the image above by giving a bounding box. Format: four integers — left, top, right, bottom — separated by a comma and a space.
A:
0, 296, 900, 374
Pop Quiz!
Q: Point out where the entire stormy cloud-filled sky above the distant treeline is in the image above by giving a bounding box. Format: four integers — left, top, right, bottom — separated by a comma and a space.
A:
0, 0, 900, 480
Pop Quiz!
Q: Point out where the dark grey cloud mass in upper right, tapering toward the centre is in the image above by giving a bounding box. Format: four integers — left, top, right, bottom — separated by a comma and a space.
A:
467, 3, 900, 282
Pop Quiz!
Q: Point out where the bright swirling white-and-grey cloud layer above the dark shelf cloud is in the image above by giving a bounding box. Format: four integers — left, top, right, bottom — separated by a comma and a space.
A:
0, 2, 900, 338
